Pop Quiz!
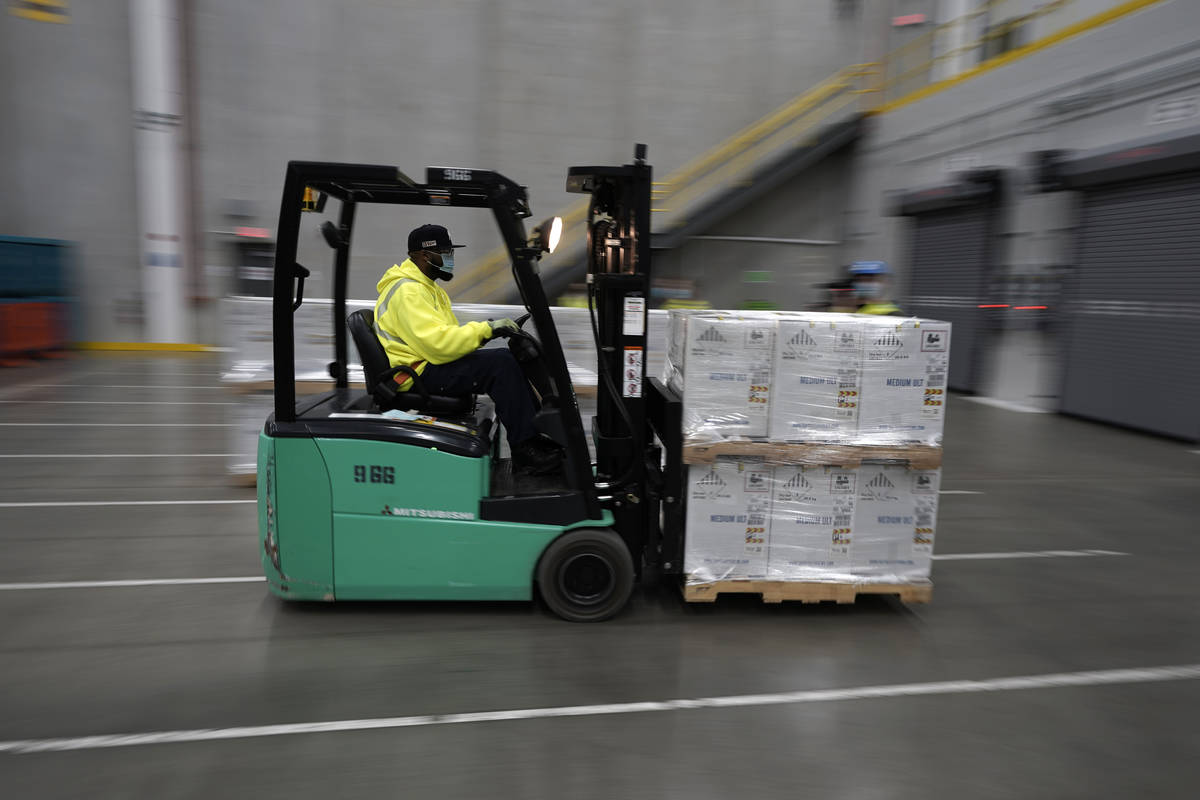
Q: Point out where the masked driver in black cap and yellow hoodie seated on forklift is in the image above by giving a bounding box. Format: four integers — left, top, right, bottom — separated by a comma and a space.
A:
374, 225, 563, 475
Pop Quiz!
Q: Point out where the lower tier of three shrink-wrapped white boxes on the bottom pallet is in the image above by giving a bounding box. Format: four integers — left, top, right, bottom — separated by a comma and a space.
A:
684, 457, 941, 583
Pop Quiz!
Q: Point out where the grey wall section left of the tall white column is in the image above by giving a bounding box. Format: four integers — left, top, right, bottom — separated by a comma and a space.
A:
0, 0, 142, 341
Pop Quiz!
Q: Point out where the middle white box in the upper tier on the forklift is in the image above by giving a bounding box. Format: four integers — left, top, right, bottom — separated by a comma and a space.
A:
768, 314, 863, 444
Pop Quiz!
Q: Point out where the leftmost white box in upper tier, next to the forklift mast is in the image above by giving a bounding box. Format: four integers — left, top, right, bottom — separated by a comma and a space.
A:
671, 313, 776, 439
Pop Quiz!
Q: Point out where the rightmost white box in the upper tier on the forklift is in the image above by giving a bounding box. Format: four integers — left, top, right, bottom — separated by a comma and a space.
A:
856, 317, 950, 446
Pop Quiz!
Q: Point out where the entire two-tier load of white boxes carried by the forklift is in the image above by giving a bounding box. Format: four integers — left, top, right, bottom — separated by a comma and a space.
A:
665, 312, 950, 592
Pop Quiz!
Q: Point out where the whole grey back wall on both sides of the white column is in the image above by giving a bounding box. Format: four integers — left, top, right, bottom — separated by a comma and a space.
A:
0, 0, 868, 341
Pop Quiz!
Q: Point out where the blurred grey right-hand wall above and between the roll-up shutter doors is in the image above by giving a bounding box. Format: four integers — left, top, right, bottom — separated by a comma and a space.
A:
845, 0, 1200, 401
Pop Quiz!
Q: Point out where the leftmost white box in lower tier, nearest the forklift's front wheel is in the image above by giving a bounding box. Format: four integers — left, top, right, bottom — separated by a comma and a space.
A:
684, 458, 770, 582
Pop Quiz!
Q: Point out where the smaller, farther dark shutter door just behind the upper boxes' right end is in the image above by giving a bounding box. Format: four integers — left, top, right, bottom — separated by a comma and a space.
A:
904, 204, 992, 392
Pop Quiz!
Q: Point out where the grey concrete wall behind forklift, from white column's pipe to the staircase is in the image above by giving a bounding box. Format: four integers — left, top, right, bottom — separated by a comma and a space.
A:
194, 0, 873, 338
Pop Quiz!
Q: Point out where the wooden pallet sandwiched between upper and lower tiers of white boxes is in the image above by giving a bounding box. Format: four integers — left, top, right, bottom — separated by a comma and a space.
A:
683, 439, 942, 469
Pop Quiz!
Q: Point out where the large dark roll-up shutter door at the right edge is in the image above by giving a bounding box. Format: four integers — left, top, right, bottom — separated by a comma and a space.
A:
1062, 172, 1200, 440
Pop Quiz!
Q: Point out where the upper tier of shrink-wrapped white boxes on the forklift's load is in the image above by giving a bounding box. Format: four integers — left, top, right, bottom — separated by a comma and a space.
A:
664, 311, 950, 446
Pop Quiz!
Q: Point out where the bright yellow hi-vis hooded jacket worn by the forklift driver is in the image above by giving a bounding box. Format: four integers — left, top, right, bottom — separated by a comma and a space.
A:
376, 259, 492, 391
